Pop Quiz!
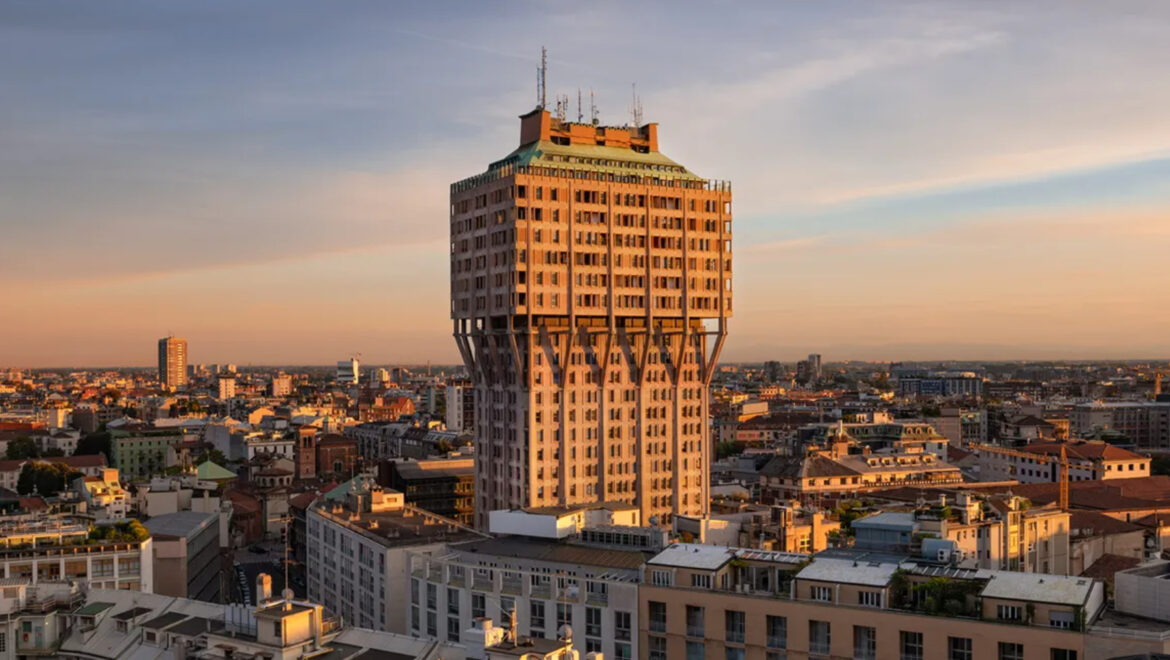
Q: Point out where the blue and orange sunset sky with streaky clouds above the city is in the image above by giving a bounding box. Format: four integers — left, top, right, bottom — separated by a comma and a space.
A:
0, 0, 1170, 366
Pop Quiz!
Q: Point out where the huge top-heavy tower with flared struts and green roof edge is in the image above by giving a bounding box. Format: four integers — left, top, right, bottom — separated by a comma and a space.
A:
450, 106, 731, 527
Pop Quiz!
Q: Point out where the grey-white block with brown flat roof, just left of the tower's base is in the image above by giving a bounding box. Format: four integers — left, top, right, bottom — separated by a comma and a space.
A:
305, 476, 483, 633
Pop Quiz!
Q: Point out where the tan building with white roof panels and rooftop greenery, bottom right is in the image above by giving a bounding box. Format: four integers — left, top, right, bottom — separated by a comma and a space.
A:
639, 544, 1108, 660
